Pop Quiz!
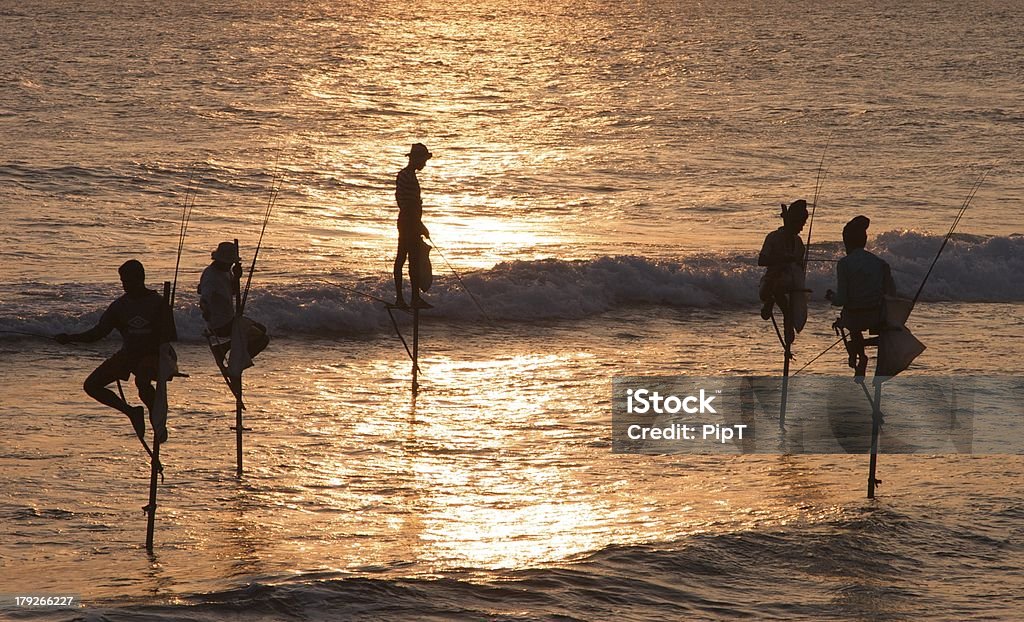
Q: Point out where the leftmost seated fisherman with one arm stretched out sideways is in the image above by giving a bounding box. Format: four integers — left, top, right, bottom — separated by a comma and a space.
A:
54, 259, 177, 444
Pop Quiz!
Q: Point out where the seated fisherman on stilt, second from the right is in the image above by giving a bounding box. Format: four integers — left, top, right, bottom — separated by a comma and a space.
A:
758, 199, 807, 343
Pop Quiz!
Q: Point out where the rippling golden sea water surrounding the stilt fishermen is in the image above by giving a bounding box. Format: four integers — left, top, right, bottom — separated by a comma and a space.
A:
0, 0, 1024, 620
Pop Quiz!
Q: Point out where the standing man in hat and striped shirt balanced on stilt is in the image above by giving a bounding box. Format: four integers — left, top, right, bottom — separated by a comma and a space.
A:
394, 142, 433, 308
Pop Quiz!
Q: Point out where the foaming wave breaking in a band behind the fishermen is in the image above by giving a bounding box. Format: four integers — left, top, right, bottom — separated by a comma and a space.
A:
0, 232, 1024, 340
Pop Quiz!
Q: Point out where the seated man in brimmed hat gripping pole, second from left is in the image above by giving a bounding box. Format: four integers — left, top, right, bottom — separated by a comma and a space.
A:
199, 242, 270, 366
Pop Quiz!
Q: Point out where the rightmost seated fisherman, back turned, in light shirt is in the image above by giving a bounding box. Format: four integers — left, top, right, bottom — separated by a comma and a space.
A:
825, 216, 896, 378
